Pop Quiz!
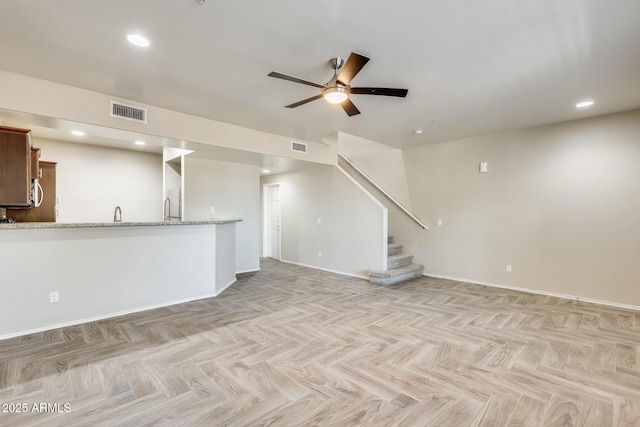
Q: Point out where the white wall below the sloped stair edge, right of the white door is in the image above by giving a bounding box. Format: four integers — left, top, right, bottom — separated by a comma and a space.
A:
262, 166, 387, 277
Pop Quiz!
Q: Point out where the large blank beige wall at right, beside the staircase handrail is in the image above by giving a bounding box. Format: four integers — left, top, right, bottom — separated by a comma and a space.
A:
402, 110, 640, 306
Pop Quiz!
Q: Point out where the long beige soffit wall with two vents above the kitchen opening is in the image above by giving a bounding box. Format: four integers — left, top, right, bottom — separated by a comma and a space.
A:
0, 70, 336, 164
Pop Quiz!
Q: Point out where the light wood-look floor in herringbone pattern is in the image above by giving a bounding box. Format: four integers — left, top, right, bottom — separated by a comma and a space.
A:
0, 260, 640, 426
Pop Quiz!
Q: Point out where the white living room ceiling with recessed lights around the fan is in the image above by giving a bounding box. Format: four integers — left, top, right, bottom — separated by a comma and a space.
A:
0, 0, 640, 148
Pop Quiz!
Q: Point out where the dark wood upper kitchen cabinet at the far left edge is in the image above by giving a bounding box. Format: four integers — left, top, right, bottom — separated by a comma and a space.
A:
0, 126, 32, 207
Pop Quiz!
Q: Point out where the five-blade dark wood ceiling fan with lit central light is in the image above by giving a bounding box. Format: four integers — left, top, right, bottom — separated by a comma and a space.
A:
269, 52, 408, 116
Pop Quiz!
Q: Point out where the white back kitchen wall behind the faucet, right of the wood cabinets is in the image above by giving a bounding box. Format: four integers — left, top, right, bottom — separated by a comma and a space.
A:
33, 138, 163, 222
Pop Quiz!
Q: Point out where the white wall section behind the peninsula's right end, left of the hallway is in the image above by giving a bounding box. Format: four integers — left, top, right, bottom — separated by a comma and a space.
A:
183, 155, 260, 272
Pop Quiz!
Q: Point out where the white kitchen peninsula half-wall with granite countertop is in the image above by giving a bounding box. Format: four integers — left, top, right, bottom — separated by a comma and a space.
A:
0, 219, 241, 339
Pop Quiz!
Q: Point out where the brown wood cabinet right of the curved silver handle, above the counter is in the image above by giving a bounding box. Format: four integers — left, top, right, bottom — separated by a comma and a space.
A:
7, 161, 57, 222
